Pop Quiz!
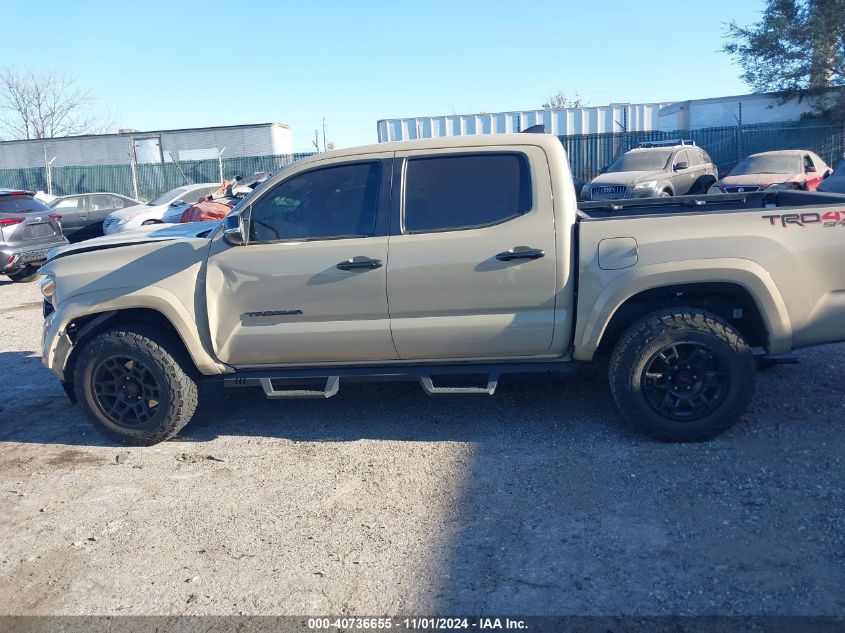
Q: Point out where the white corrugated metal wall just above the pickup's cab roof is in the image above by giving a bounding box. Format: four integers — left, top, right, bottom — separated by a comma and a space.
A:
377, 103, 667, 143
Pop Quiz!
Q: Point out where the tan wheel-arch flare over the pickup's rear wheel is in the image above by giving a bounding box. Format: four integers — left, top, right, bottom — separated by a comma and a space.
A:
573, 258, 792, 360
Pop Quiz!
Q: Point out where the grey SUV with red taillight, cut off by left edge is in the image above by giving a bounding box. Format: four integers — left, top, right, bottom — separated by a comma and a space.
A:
0, 189, 68, 281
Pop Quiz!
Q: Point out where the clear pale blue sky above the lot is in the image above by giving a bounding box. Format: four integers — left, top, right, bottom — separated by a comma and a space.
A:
0, 0, 763, 151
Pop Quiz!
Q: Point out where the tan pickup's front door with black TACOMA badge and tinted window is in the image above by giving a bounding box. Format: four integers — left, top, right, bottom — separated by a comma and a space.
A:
206, 153, 397, 367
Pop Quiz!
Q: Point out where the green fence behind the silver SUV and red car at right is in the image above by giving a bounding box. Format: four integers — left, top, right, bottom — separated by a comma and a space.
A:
559, 121, 845, 180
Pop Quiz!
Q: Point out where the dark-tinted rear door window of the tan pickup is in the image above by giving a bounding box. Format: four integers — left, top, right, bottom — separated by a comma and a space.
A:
404, 153, 531, 233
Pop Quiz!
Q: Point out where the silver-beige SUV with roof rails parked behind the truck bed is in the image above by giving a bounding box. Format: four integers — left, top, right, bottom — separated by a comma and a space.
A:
581, 140, 719, 200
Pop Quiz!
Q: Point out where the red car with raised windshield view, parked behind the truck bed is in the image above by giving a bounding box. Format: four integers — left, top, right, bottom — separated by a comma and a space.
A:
708, 149, 830, 193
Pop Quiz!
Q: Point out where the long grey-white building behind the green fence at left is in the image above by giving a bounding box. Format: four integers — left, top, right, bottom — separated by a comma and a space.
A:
0, 123, 293, 169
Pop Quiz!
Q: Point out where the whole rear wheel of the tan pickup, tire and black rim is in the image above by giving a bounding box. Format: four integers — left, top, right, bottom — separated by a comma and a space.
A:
609, 308, 756, 442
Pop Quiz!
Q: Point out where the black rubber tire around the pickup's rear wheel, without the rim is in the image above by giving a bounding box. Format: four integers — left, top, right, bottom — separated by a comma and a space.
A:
608, 307, 757, 442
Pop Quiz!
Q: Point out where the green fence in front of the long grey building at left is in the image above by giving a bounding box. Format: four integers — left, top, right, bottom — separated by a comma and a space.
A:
0, 153, 312, 201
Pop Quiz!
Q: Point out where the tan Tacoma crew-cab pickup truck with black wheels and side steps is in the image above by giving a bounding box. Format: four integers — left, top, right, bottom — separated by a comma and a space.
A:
40, 134, 845, 444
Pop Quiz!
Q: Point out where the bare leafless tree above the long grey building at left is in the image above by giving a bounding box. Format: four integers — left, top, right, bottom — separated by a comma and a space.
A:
0, 66, 102, 139
